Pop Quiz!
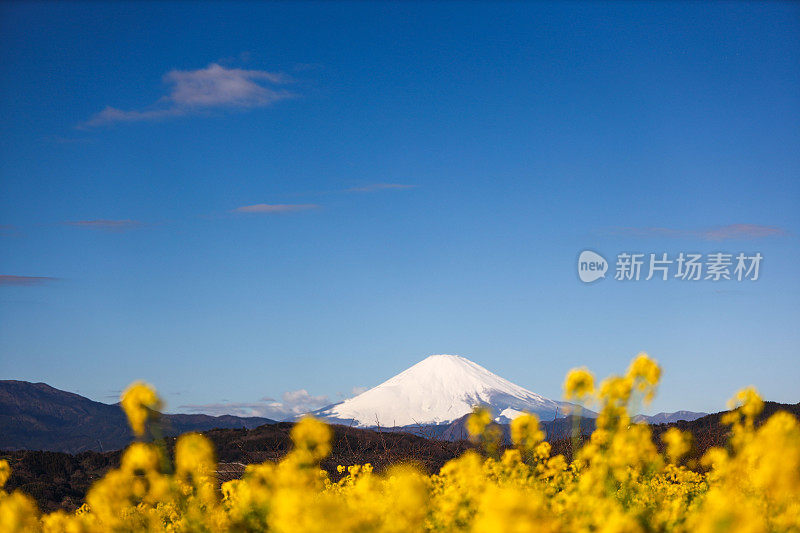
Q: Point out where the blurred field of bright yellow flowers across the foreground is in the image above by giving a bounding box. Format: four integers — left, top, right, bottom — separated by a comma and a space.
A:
0, 354, 800, 533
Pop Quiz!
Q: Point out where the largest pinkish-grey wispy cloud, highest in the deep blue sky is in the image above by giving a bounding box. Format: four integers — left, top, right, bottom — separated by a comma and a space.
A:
81, 63, 295, 127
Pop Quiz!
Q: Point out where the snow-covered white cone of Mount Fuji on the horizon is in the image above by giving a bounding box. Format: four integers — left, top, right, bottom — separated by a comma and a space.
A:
312, 355, 580, 427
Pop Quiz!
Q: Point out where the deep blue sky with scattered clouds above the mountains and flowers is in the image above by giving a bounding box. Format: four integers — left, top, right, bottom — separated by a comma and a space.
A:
0, 2, 800, 414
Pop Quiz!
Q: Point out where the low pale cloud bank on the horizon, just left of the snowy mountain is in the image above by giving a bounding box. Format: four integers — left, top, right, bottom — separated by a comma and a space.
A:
179, 389, 330, 420
